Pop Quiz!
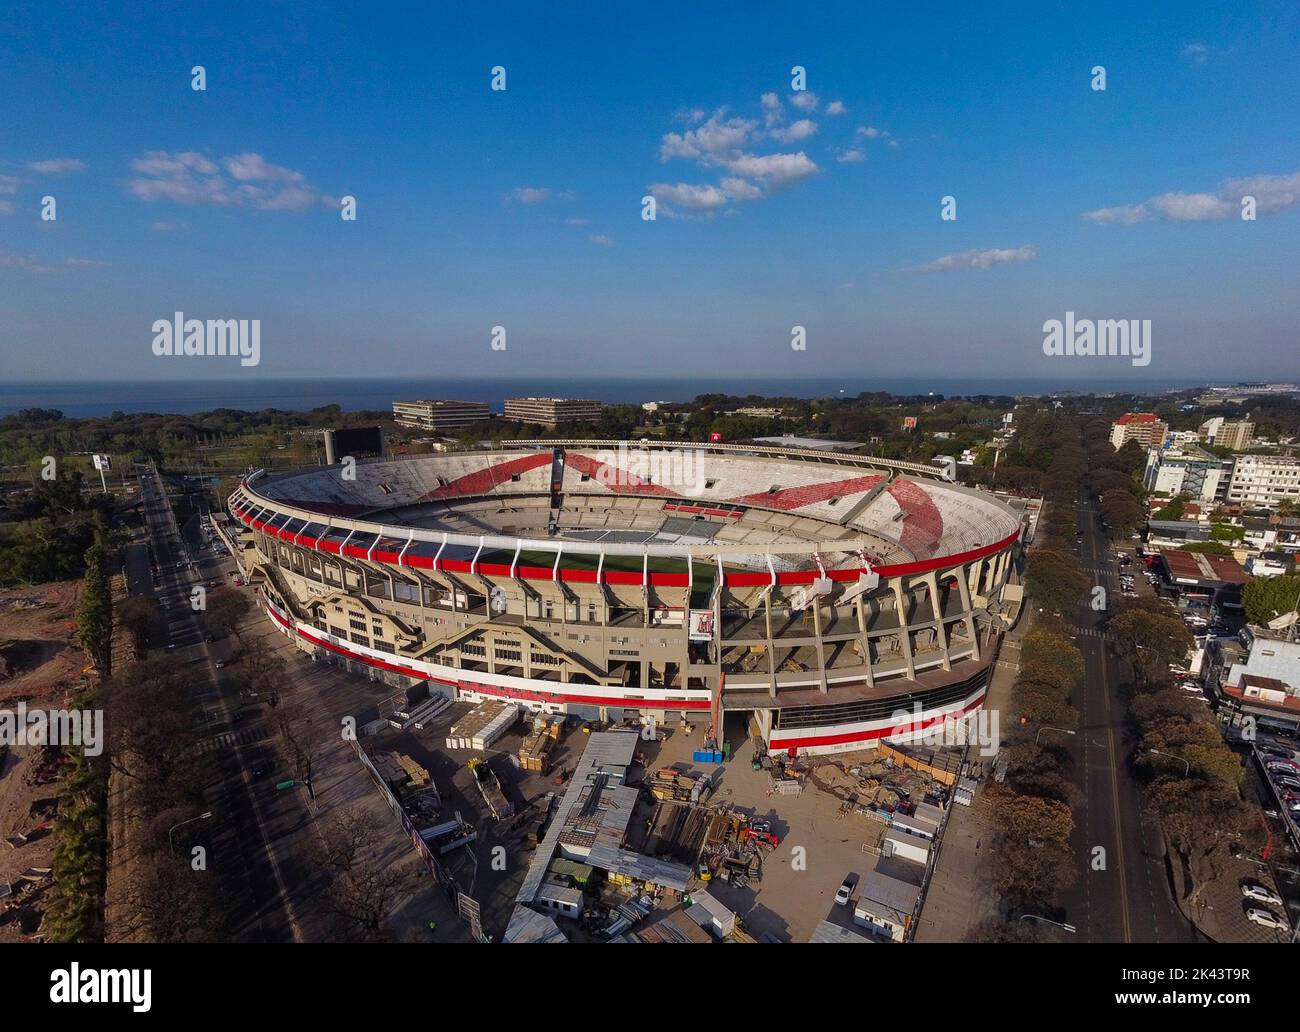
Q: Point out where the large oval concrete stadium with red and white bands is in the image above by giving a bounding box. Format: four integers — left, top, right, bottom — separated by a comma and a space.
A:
228, 441, 1023, 753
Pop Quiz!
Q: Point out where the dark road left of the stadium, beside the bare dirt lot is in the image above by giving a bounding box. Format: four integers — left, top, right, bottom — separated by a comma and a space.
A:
129, 464, 311, 942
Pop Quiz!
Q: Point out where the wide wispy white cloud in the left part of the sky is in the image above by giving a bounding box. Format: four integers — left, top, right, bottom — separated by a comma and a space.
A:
125, 151, 329, 212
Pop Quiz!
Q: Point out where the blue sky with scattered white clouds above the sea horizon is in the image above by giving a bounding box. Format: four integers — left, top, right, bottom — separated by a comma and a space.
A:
0, 3, 1300, 386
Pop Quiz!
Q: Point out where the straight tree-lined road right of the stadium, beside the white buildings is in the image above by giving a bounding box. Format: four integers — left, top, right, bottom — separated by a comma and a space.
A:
1063, 490, 1204, 942
